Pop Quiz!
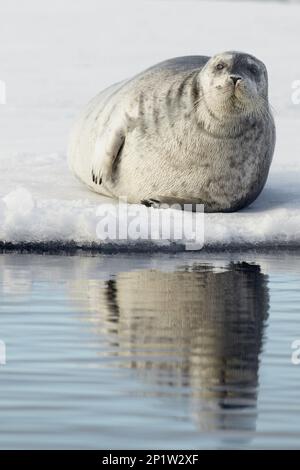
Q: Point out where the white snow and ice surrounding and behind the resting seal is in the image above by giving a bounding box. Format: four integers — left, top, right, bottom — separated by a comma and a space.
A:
0, 0, 300, 248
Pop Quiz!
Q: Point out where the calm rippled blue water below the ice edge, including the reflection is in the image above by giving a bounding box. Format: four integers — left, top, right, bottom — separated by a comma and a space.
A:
0, 253, 300, 449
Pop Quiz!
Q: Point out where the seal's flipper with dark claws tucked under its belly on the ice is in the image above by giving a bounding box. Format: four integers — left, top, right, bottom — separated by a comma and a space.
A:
141, 196, 203, 212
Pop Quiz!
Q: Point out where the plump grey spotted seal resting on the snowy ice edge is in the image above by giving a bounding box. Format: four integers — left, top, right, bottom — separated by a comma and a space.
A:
68, 51, 275, 212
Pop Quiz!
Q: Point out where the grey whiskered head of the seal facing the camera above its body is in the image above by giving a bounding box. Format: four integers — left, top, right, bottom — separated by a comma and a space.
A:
200, 52, 268, 118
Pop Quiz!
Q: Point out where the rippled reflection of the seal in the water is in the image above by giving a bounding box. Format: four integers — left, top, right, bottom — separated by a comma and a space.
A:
73, 263, 269, 431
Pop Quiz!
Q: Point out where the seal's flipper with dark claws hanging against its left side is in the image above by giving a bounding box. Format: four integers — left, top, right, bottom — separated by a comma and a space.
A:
91, 121, 126, 185
